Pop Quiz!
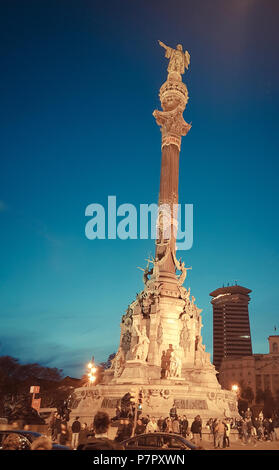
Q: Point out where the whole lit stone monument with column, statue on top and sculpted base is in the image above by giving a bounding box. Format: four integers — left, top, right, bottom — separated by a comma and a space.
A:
71, 41, 238, 423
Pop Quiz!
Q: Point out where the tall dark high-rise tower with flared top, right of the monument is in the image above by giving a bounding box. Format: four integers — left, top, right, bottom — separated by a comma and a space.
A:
210, 285, 252, 371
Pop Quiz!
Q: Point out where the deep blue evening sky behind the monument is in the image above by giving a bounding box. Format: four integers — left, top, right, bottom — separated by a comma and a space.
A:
0, 0, 279, 377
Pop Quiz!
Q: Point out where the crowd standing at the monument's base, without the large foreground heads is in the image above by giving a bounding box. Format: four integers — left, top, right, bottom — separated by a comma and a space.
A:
48, 408, 279, 449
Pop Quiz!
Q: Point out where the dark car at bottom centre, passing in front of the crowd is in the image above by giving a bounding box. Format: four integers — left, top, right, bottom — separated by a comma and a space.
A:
121, 432, 198, 450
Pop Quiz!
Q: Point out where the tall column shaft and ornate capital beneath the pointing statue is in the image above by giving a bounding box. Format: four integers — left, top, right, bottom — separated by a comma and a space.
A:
153, 73, 191, 282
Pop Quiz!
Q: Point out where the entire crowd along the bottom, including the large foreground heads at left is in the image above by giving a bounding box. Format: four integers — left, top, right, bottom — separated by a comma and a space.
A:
2, 408, 279, 450
